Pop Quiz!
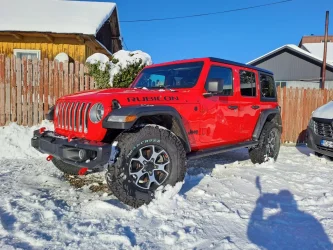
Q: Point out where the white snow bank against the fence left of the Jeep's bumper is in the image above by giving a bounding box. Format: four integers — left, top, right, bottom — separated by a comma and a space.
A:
0, 121, 53, 159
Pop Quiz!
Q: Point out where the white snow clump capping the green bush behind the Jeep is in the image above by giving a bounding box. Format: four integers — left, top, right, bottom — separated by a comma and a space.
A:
86, 50, 153, 86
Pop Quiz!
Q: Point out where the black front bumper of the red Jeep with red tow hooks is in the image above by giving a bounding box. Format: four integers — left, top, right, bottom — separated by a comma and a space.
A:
31, 130, 111, 172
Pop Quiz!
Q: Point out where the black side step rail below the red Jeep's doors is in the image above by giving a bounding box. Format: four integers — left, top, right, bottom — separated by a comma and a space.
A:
187, 141, 258, 160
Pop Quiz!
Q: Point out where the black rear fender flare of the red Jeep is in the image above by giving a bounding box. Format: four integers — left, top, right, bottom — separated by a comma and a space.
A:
252, 108, 282, 141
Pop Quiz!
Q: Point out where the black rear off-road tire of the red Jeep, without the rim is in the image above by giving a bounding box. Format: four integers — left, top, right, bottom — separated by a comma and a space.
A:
249, 122, 281, 164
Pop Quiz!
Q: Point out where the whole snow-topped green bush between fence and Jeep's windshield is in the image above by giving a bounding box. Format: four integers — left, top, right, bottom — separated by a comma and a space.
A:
86, 50, 152, 88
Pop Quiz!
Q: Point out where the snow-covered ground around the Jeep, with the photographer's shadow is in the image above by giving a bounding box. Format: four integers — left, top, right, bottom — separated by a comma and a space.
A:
0, 124, 333, 249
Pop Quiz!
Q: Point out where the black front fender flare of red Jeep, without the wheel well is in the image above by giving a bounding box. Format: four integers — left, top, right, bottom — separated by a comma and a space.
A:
102, 105, 191, 153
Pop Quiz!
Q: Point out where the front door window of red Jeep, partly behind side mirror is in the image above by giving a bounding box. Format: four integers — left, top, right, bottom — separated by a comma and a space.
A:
205, 66, 233, 96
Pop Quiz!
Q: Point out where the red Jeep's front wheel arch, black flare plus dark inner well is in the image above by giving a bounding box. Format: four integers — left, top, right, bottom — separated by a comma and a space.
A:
102, 105, 191, 153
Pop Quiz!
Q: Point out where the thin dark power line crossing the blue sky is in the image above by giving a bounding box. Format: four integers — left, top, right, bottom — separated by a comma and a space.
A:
120, 0, 293, 23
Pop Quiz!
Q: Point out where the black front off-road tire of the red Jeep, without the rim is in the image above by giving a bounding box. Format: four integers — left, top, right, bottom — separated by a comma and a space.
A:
106, 125, 186, 208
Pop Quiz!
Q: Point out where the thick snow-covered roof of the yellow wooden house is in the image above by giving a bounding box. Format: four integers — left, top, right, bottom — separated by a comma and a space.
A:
0, 0, 116, 35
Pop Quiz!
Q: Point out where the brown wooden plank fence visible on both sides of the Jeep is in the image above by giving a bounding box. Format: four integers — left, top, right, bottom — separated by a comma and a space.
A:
0, 55, 333, 143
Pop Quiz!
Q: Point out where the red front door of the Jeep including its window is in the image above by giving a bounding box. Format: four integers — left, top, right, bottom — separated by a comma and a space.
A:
200, 64, 241, 146
